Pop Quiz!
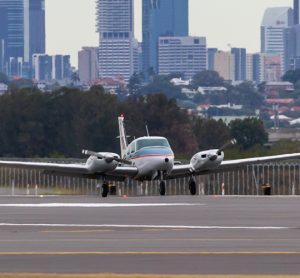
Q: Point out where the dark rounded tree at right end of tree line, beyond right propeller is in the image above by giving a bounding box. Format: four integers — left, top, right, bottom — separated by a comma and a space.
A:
229, 118, 268, 150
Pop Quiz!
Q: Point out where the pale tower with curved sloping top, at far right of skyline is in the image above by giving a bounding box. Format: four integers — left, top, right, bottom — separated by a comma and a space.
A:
261, 7, 294, 73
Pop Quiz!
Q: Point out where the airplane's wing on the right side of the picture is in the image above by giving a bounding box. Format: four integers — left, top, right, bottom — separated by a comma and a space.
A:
167, 153, 300, 179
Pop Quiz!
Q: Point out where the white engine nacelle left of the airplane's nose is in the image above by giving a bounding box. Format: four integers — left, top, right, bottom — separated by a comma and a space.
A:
86, 153, 120, 173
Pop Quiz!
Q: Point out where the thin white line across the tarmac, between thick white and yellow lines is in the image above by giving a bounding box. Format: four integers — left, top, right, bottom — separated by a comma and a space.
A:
0, 223, 300, 230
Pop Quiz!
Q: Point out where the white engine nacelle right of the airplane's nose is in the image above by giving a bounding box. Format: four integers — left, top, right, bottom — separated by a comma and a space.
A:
190, 150, 224, 172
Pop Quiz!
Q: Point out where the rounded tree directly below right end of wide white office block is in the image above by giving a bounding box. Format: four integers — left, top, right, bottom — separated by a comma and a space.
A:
191, 70, 225, 89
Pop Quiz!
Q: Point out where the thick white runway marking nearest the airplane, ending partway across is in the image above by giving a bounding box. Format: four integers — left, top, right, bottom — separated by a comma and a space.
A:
0, 203, 203, 208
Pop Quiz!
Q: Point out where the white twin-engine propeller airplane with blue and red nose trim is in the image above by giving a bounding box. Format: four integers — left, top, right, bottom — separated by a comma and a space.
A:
0, 116, 300, 197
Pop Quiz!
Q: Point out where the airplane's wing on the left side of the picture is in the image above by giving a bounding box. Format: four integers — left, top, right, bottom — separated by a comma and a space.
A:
0, 160, 138, 181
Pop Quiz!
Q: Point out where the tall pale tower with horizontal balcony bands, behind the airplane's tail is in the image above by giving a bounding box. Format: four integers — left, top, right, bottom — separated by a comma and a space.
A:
97, 0, 136, 80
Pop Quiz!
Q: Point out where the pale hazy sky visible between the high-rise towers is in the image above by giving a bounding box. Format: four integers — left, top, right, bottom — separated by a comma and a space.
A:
46, 0, 293, 67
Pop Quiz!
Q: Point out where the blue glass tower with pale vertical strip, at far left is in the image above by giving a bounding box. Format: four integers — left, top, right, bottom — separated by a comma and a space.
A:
0, 0, 45, 74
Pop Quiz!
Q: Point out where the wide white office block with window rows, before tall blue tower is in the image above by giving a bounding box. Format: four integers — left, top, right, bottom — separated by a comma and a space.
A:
158, 37, 207, 79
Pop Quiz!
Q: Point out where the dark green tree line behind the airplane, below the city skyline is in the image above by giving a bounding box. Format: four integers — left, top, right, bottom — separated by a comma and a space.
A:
0, 86, 267, 158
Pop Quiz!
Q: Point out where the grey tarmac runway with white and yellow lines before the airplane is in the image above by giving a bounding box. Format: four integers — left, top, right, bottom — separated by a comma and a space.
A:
0, 196, 300, 275
